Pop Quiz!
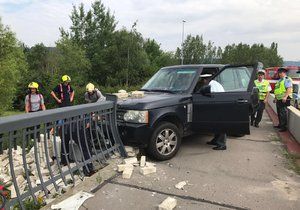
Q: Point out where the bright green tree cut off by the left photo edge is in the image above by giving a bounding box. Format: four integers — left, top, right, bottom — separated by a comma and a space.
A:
0, 19, 27, 115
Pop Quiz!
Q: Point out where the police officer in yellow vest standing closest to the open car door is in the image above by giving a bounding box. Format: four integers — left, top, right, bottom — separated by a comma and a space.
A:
251, 69, 272, 128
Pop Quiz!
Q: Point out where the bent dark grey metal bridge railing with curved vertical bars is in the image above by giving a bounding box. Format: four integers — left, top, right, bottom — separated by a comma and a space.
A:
0, 96, 126, 209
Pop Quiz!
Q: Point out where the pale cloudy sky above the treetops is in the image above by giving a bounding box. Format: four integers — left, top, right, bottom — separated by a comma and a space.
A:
0, 0, 300, 61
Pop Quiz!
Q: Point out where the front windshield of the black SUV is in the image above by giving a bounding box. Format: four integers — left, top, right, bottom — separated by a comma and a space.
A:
142, 68, 197, 92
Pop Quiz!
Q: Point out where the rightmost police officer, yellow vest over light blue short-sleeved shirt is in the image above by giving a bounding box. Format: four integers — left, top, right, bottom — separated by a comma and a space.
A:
274, 68, 293, 132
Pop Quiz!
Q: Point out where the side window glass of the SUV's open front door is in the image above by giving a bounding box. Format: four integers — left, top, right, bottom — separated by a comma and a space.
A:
215, 67, 253, 92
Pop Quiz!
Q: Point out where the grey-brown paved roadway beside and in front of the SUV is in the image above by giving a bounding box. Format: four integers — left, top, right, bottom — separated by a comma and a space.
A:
80, 115, 300, 210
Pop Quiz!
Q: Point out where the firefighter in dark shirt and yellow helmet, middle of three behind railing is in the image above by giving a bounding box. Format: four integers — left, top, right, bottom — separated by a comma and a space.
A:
51, 75, 74, 107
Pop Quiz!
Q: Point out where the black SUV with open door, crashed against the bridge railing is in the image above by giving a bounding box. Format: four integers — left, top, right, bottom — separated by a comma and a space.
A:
117, 64, 258, 160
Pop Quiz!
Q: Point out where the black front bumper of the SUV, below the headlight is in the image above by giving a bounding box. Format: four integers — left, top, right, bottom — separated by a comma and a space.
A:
117, 122, 152, 147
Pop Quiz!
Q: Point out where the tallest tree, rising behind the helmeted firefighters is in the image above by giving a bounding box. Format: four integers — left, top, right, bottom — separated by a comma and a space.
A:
61, 1, 116, 84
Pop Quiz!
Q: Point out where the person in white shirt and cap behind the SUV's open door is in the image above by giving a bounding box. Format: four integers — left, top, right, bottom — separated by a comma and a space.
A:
200, 74, 227, 150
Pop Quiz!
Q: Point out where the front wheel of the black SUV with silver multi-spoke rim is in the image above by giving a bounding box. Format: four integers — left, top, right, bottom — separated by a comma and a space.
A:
148, 122, 181, 160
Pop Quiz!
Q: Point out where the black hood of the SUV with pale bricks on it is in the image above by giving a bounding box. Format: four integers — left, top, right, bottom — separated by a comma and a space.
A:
117, 93, 189, 110
